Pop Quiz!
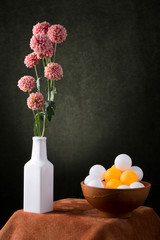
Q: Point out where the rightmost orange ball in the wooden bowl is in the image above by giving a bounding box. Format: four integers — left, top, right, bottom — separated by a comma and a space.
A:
120, 170, 138, 186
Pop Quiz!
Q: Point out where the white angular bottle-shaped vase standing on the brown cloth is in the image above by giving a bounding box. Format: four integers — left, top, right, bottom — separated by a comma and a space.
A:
23, 137, 54, 213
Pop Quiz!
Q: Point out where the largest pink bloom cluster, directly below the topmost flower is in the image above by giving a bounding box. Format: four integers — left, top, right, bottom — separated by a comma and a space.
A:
30, 33, 54, 58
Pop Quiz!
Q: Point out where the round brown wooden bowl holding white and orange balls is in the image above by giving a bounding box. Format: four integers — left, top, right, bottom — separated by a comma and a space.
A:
81, 181, 151, 218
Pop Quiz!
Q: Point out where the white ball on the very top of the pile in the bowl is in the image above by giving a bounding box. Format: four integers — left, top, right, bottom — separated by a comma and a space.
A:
114, 154, 132, 171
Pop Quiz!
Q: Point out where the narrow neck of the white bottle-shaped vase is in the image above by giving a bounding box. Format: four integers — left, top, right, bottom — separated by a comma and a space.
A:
31, 137, 47, 161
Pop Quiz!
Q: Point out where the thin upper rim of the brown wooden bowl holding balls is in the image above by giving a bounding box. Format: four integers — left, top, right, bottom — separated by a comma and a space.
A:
80, 181, 151, 191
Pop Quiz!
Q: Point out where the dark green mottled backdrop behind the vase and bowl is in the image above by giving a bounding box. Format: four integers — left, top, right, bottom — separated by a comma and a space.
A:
0, 0, 160, 229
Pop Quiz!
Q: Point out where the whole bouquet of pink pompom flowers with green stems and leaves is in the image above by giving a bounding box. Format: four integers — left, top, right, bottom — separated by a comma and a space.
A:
18, 21, 67, 137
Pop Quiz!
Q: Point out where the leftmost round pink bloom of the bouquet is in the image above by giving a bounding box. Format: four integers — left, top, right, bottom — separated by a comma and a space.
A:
17, 76, 36, 92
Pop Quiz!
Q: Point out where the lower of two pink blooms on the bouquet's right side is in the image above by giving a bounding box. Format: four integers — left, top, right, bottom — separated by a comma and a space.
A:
44, 63, 63, 80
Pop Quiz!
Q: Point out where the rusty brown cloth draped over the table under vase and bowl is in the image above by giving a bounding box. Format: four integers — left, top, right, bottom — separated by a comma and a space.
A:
0, 199, 160, 240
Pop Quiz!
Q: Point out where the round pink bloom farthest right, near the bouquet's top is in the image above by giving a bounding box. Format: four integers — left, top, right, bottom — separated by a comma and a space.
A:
47, 24, 67, 43
